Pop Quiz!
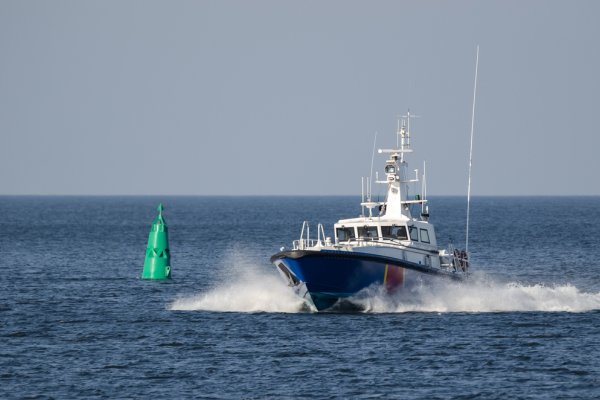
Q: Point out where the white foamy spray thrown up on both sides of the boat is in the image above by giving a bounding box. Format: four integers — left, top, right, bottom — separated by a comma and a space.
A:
169, 250, 600, 313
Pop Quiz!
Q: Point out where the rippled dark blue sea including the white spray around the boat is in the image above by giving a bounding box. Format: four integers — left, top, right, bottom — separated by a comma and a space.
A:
0, 196, 600, 399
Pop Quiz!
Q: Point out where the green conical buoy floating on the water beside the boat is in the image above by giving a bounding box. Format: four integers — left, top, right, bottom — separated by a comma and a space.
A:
142, 203, 171, 280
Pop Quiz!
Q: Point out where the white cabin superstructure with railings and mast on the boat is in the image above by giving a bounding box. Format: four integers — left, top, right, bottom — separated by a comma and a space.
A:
294, 112, 468, 272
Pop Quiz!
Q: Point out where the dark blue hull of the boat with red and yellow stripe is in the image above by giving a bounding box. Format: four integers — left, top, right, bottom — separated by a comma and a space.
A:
271, 250, 461, 311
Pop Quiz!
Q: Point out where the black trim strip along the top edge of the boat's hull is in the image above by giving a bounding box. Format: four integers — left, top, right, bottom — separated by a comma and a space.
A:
271, 250, 468, 280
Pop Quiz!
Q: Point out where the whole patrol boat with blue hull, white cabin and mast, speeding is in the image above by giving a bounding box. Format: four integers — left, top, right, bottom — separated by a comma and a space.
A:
271, 112, 469, 311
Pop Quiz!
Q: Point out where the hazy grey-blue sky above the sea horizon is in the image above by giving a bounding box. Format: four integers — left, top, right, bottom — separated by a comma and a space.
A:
0, 0, 600, 195
